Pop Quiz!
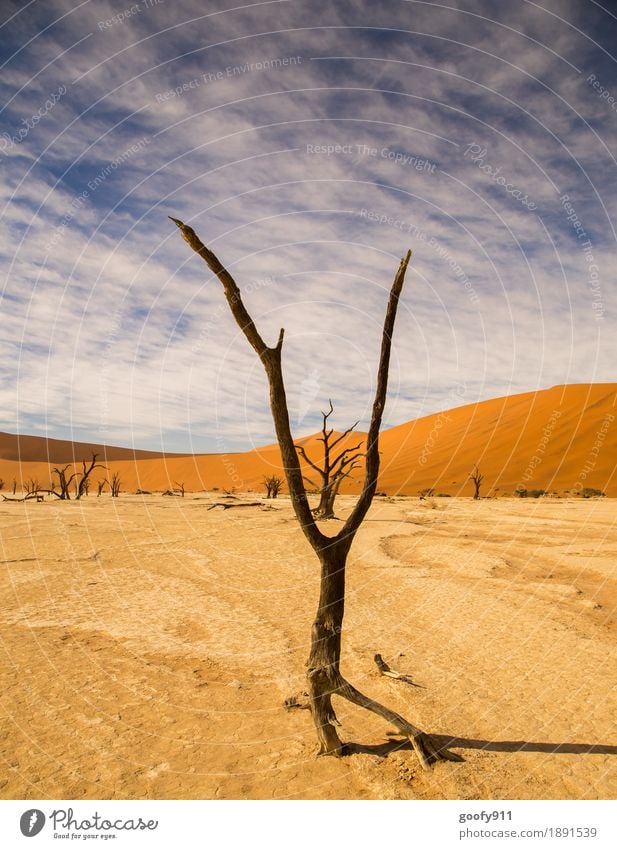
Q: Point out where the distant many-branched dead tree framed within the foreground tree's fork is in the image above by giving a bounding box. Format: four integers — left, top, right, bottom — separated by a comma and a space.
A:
296, 401, 364, 519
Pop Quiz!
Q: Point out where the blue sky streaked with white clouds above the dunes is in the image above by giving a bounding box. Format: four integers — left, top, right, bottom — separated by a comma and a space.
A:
0, 0, 617, 451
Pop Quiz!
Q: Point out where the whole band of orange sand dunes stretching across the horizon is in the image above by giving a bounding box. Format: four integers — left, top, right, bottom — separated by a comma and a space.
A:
0, 383, 617, 496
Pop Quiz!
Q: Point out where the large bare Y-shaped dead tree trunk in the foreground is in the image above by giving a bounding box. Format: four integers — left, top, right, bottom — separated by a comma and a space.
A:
172, 218, 456, 769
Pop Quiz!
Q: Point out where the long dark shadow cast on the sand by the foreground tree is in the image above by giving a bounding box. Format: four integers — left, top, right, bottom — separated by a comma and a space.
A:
345, 734, 617, 761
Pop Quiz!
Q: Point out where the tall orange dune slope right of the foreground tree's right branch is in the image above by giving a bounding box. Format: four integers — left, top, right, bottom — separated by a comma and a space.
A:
380, 383, 617, 496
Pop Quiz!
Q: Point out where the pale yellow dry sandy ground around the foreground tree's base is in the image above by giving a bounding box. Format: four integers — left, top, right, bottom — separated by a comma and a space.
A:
0, 494, 617, 799
